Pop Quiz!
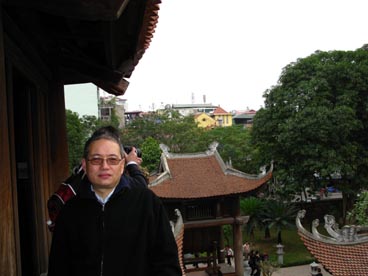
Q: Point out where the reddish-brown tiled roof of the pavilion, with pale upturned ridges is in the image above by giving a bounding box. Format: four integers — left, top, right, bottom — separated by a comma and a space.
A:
150, 147, 272, 199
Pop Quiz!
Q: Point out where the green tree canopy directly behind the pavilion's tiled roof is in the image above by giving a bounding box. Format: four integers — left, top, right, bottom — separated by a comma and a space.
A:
122, 111, 262, 173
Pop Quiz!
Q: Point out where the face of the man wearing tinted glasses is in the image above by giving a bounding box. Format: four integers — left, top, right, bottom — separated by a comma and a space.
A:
82, 139, 125, 189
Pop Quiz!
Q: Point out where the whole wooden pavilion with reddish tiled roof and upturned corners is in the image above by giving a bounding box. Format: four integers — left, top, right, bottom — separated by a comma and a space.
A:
149, 142, 272, 276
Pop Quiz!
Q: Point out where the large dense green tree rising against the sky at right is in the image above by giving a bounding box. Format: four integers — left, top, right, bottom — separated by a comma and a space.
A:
252, 47, 368, 220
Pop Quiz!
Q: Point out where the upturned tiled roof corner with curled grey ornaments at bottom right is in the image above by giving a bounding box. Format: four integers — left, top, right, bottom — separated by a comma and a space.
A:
296, 210, 368, 276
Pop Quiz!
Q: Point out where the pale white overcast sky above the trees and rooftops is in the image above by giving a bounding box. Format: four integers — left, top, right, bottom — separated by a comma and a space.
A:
123, 0, 368, 112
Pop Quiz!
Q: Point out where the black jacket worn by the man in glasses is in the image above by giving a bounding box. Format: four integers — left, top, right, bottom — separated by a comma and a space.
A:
48, 171, 182, 276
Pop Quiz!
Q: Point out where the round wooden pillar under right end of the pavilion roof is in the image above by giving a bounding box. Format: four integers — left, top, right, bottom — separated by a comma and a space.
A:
233, 197, 244, 276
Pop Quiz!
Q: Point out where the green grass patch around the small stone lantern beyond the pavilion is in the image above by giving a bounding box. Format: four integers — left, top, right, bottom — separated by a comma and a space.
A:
244, 226, 315, 267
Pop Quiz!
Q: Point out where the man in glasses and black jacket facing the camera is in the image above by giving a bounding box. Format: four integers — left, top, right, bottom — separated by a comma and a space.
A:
48, 127, 181, 276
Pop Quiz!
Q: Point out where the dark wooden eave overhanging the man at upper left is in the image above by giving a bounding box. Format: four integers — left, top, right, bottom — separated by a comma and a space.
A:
2, 0, 160, 95
